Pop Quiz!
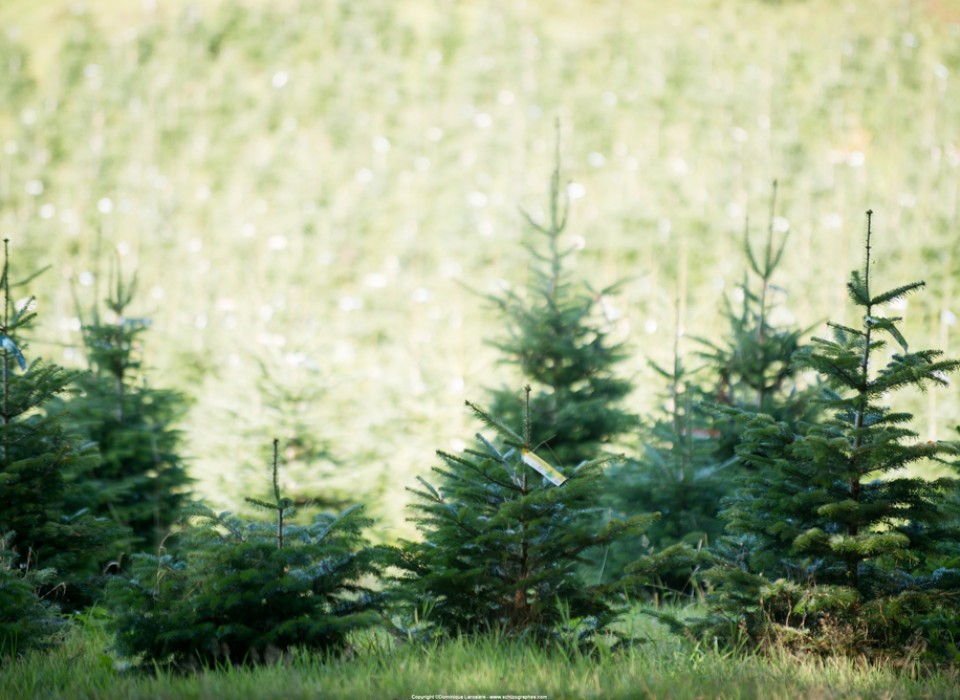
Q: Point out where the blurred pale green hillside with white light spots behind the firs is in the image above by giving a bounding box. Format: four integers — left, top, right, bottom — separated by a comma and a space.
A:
0, 0, 960, 537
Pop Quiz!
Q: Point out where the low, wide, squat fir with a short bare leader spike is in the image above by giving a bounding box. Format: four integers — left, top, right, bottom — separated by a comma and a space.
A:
108, 441, 382, 668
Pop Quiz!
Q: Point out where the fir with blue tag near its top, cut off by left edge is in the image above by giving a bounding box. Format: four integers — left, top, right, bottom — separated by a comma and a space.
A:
0, 240, 124, 610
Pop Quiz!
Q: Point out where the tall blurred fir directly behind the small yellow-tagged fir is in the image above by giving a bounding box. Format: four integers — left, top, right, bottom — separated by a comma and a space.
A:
490, 146, 637, 467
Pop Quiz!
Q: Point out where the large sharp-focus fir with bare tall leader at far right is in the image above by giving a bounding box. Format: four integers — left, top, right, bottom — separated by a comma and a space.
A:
699, 212, 960, 653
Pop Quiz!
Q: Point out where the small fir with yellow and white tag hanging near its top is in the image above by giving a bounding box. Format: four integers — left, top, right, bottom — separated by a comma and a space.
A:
395, 387, 655, 641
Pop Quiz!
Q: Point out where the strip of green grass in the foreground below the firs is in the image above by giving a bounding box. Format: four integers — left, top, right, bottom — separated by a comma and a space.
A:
7, 618, 960, 700
